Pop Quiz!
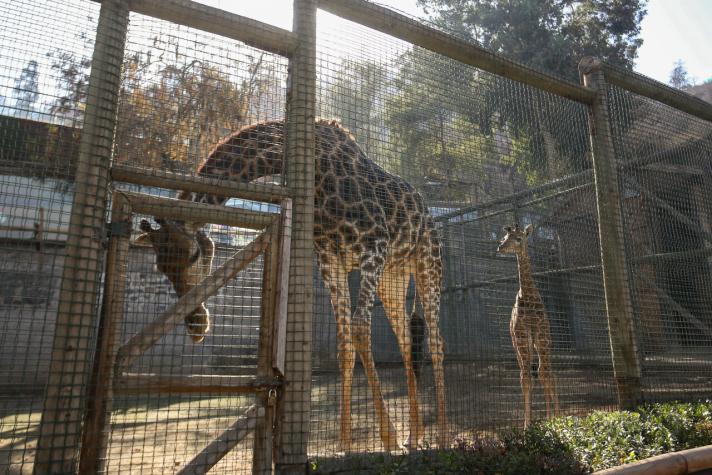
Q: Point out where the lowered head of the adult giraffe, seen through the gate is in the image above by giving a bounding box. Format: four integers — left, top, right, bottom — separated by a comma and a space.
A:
136, 218, 215, 343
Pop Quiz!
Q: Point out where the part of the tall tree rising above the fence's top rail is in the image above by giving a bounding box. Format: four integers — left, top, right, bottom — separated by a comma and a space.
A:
418, 0, 646, 82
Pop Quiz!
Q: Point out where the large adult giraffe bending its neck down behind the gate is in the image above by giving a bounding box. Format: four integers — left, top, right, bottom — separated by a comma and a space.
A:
136, 120, 448, 451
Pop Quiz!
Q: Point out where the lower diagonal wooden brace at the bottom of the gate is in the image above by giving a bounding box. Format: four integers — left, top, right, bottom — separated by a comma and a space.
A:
177, 404, 265, 475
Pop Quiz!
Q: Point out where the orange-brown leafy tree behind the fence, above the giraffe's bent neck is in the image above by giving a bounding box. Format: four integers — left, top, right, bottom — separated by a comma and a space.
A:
49, 37, 275, 169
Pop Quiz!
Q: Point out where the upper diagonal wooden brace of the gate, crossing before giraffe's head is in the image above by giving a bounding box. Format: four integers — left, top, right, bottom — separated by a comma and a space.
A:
115, 232, 270, 374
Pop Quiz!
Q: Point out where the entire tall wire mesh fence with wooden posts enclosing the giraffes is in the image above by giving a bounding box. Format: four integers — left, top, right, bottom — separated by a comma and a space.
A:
0, 0, 712, 473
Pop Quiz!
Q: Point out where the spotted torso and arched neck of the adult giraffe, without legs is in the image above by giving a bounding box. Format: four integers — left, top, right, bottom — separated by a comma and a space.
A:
192, 120, 440, 270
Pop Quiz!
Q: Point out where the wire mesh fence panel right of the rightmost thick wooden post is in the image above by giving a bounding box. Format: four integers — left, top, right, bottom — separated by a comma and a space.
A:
608, 86, 712, 401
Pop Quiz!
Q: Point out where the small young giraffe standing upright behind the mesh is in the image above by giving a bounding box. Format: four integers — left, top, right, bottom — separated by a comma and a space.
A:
497, 224, 559, 428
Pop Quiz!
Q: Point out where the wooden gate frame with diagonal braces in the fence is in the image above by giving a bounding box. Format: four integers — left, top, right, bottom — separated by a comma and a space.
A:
79, 188, 291, 475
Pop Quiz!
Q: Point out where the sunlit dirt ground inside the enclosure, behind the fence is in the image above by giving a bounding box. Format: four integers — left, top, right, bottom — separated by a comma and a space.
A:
0, 359, 712, 474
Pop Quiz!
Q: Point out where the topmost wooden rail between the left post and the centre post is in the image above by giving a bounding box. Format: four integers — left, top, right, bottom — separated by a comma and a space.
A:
129, 0, 297, 56
